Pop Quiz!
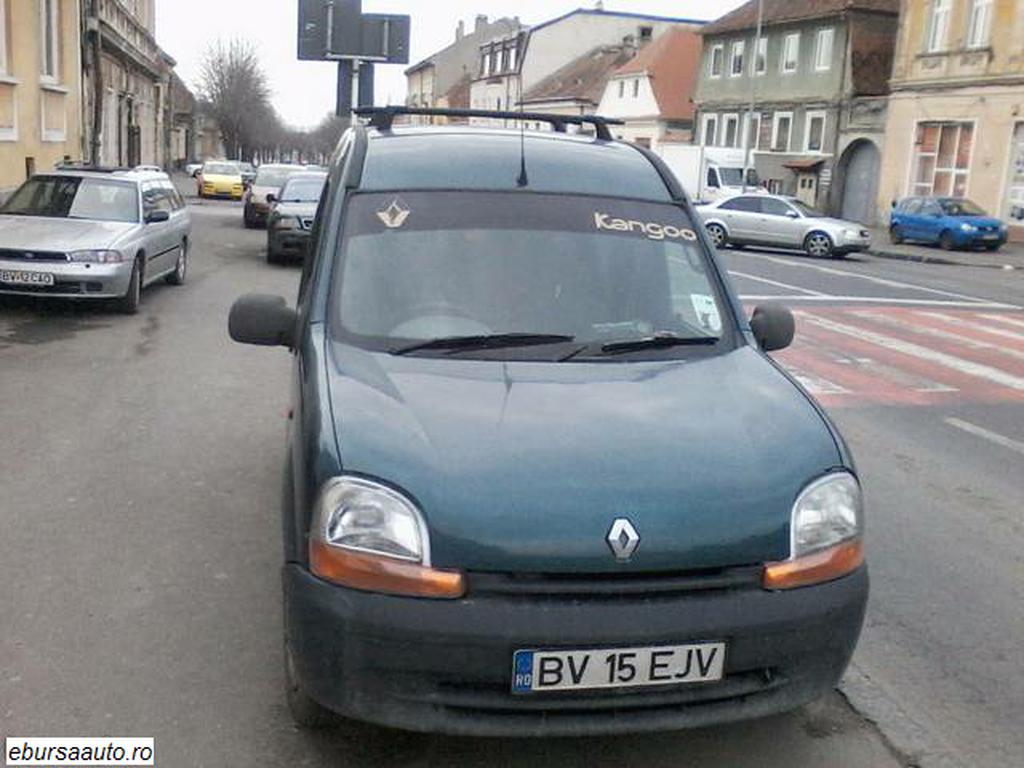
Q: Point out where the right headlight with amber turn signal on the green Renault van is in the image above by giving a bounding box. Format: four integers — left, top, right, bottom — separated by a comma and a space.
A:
764, 472, 864, 590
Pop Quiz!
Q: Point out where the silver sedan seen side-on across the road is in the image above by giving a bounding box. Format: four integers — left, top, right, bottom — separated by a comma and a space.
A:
696, 194, 871, 258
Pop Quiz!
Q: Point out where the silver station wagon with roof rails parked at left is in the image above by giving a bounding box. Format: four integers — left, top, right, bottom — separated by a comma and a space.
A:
0, 170, 191, 313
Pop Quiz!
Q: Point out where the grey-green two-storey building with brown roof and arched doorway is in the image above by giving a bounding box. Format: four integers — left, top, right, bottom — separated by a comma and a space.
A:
694, 0, 899, 223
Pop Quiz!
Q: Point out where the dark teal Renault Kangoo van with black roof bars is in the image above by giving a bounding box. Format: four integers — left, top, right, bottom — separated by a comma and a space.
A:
229, 108, 868, 736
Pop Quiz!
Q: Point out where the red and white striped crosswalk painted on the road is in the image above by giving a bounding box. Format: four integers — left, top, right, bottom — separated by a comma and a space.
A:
775, 305, 1024, 408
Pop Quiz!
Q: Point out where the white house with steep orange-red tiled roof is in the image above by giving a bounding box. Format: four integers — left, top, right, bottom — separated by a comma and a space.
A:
598, 27, 700, 151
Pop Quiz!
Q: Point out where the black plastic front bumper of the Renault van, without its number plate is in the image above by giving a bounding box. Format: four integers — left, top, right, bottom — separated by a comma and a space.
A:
283, 564, 868, 736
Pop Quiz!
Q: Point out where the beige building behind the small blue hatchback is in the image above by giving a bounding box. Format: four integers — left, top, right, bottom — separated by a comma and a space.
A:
879, 0, 1024, 240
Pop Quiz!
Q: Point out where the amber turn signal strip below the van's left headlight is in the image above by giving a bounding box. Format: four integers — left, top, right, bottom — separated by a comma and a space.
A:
309, 541, 466, 600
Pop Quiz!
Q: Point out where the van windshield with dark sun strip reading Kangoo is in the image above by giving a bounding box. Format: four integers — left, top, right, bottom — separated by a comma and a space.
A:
333, 191, 728, 359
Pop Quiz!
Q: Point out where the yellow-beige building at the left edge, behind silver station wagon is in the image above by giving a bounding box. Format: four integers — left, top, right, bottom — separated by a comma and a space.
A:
0, 0, 82, 197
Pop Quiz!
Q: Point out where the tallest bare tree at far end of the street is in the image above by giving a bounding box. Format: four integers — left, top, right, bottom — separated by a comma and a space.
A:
199, 40, 276, 160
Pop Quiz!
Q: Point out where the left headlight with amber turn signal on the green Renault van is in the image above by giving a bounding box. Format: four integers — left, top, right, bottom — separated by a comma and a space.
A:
309, 475, 465, 598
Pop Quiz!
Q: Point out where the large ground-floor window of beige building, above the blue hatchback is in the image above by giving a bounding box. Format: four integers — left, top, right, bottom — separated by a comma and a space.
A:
910, 122, 974, 198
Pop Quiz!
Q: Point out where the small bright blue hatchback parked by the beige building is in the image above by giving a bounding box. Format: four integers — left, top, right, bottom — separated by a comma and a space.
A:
889, 198, 1008, 251
